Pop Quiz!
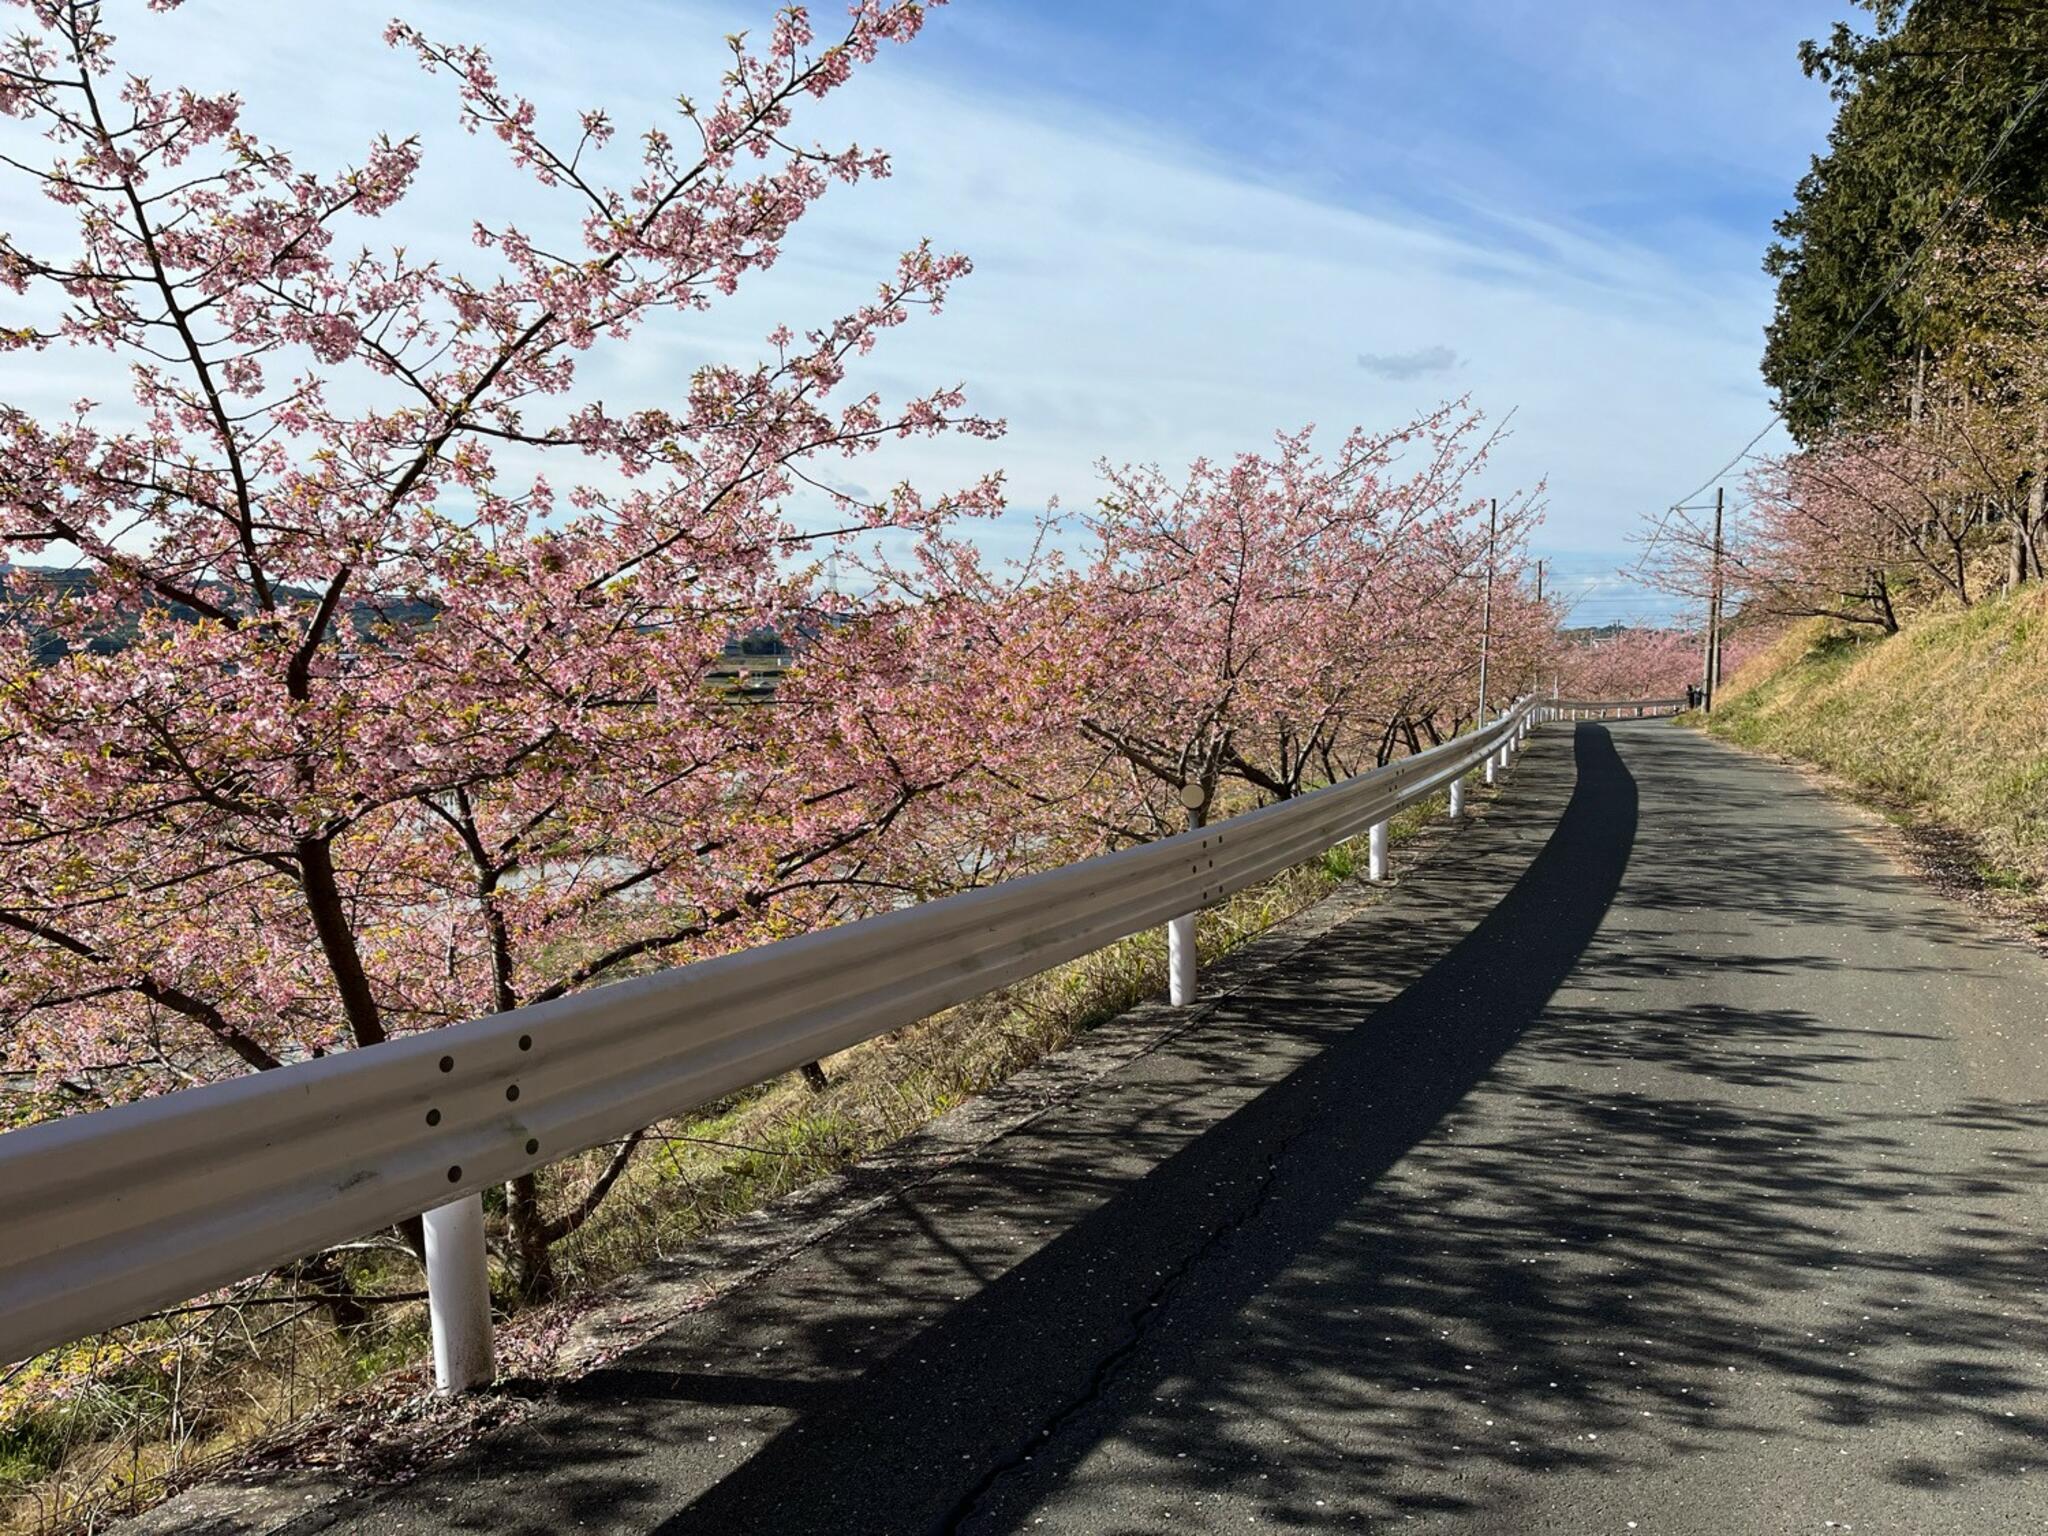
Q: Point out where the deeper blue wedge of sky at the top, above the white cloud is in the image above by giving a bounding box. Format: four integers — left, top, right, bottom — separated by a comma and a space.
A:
928, 0, 1843, 256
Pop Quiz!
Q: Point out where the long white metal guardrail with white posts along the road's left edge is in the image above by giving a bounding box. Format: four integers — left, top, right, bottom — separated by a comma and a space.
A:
0, 700, 1616, 1391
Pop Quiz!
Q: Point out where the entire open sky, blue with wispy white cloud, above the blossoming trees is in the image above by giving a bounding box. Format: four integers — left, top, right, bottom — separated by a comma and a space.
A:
0, 0, 1847, 621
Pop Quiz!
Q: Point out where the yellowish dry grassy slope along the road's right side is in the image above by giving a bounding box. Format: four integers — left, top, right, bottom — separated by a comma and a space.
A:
1710, 588, 2048, 897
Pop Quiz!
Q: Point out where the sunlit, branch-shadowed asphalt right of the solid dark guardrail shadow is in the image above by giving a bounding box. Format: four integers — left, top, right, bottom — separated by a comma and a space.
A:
942, 727, 2048, 1532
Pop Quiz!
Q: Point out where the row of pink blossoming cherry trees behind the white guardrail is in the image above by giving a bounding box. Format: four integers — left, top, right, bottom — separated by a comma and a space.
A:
0, 0, 1552, 1318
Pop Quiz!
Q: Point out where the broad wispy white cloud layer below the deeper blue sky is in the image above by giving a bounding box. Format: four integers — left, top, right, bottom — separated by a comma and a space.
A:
0, 0, 1810, 577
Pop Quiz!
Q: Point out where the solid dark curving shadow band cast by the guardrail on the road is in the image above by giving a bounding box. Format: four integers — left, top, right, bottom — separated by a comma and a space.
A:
598, 727, 1636, 1534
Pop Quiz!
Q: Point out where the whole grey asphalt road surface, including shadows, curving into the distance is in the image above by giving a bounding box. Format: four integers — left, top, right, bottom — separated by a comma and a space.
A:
280, 723, 2048, 1536
